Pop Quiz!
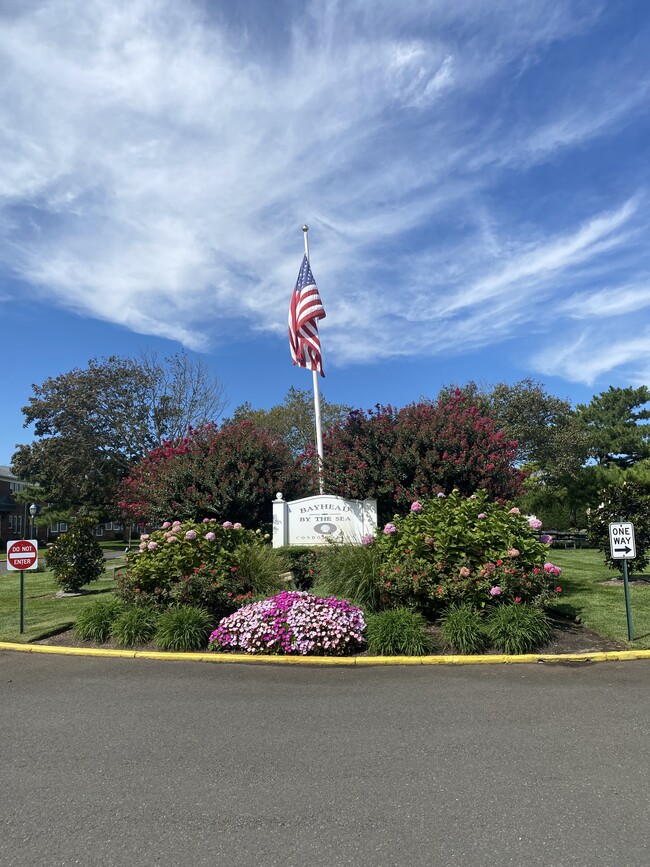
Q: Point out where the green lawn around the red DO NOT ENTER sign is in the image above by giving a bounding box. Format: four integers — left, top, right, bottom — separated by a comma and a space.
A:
0, 570, 115, 642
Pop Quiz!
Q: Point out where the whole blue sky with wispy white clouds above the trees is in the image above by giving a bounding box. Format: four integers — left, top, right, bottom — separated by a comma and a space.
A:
0, 0, 650, 464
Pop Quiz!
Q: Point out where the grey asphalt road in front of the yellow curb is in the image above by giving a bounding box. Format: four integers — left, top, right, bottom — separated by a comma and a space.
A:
0, 652, 650, 867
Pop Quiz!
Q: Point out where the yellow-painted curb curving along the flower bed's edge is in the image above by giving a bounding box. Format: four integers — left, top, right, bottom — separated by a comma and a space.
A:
0, 641, 650, 666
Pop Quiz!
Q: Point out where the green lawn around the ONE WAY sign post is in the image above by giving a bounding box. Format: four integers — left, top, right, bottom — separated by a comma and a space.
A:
549, 549, 650, 649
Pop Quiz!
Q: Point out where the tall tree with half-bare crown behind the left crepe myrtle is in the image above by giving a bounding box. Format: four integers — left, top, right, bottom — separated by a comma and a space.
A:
12, 354, 224, 519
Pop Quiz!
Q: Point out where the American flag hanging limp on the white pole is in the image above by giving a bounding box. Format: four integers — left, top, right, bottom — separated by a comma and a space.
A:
289, 256, 325, 376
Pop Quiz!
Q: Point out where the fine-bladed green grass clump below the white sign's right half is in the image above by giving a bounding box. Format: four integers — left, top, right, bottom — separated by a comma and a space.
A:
313, 542, 382, 611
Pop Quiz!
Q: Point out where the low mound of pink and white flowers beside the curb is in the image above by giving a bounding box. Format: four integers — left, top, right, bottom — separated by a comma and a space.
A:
209, 590, 366, 656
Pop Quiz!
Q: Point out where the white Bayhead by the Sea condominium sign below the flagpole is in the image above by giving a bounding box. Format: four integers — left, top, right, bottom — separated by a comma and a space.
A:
273, 494, 377, 548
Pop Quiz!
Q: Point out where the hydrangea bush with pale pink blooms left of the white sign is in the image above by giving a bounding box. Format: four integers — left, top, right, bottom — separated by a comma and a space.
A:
117, 518, 286, 618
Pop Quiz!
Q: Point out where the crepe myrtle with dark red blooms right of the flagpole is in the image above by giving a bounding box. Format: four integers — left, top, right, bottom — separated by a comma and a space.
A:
316, 389, 523, 520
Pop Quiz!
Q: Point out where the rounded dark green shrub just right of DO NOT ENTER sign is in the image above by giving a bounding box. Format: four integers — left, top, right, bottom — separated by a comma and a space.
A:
45, 518, 104, 593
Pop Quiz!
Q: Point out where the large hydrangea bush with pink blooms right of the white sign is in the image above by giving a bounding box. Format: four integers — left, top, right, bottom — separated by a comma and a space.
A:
372, 491, 561, 616
